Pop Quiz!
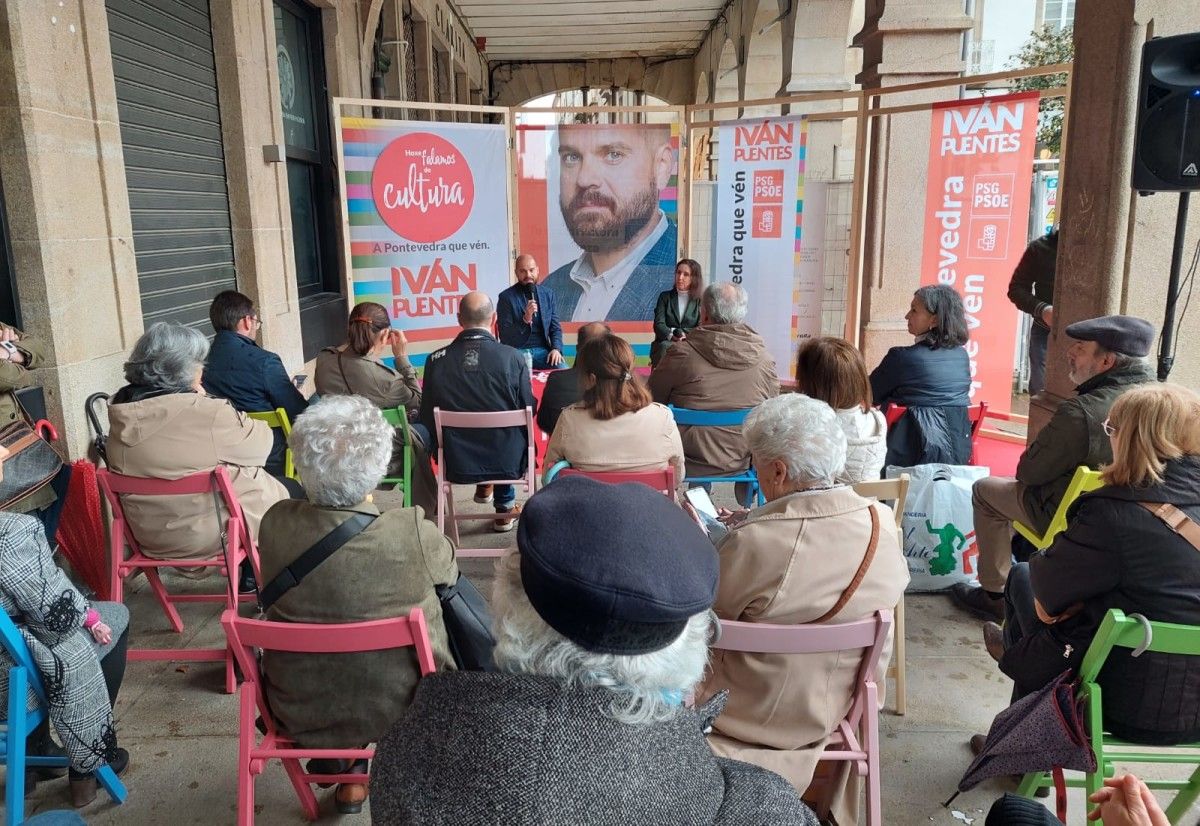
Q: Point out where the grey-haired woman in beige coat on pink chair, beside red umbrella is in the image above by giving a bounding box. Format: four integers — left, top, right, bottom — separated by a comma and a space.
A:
107, 322, 295, 566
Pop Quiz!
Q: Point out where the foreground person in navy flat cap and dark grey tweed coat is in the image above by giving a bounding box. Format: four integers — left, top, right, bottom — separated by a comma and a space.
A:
371, 477, 816, 826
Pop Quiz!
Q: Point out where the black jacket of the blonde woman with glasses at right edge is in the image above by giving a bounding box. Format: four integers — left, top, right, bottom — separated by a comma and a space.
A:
1030, 456, 1200, 744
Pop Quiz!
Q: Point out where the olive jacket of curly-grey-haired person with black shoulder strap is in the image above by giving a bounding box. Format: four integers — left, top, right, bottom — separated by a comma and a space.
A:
259, 499, 458, 748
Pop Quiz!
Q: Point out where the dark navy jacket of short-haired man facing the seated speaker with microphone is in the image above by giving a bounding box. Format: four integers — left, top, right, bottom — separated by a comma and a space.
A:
419, 329, 538, 484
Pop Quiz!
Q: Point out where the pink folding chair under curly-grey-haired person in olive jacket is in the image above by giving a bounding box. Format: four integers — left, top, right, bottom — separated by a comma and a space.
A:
221, 607, 434, 826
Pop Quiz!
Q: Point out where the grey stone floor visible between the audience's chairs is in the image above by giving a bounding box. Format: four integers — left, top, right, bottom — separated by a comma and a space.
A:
11, 487, 1196, 826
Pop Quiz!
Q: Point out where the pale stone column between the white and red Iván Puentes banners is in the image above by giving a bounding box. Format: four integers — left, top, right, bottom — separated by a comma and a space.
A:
854, 0, 973, 366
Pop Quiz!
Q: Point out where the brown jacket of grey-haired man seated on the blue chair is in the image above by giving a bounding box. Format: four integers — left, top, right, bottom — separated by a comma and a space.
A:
650, 324, 779, 475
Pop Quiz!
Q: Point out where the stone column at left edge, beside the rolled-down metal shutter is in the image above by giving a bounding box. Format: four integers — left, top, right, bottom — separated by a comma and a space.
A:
0, 2, 142, 456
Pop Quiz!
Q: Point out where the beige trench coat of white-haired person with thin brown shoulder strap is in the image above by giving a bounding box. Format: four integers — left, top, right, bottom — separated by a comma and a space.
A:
696, 487, 908, 824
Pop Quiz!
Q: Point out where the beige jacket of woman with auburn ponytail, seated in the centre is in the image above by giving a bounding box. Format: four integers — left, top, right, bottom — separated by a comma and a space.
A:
541, 403, 684, 484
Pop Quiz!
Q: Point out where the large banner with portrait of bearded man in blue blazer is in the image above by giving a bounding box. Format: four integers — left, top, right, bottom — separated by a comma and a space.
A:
517, 124, 679, 360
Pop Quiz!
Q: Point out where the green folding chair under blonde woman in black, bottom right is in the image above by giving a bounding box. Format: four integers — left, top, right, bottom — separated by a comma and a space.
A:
1016, 609, 1200, 824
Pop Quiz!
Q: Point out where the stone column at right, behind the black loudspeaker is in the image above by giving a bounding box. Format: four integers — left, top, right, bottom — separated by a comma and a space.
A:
1030, 0, 1200, 438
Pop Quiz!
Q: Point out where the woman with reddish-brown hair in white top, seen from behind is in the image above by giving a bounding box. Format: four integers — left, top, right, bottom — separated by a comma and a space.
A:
796, 339, 888, 485
